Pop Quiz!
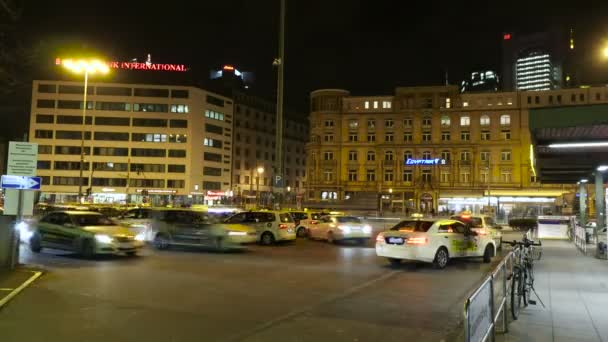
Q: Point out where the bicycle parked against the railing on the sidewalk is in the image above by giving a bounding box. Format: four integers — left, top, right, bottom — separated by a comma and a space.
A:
502, 235, 545, 320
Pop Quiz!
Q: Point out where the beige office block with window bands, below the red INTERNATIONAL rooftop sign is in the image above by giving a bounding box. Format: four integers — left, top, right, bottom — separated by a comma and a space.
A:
30, 81, 233, 204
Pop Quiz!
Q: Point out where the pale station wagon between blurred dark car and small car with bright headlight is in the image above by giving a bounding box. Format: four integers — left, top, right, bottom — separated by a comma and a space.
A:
224, 211, 296, 245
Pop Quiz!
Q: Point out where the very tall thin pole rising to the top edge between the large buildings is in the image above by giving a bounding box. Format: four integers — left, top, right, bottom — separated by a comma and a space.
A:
273, 0, 285, 210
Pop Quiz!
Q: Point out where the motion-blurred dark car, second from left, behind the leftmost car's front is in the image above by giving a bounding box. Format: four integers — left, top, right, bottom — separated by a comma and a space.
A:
150, 210, 257, 251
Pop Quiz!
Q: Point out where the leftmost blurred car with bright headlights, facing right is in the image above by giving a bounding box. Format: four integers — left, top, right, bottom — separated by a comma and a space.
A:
29, 211, 144, 258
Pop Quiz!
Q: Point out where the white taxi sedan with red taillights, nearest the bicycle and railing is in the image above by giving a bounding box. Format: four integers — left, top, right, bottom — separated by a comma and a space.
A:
376, 219, 496, 268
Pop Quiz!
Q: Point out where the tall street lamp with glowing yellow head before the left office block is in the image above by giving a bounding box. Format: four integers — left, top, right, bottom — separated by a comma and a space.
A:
61, 59, 110, 202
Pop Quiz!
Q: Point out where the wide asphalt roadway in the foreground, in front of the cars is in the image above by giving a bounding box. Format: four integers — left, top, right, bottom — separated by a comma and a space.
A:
0, 231, 508, 342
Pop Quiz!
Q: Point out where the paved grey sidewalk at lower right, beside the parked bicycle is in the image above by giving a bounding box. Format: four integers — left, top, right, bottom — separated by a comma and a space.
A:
496, 240, 608, 342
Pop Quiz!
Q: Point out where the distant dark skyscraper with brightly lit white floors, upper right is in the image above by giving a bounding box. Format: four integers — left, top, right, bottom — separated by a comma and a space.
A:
502, 30, 575, 91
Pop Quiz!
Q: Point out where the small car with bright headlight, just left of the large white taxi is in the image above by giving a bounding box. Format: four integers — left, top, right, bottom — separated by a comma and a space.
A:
308, 215, 372, 244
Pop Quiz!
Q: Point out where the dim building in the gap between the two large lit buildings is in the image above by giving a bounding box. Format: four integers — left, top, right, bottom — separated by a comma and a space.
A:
232, 91, 309, 206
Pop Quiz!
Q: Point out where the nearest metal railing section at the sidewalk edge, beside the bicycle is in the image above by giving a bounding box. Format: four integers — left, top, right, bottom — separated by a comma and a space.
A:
464, 248, 519, 342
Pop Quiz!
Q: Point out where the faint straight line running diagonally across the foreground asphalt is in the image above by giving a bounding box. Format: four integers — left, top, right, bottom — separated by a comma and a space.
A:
226, 270, 398, 341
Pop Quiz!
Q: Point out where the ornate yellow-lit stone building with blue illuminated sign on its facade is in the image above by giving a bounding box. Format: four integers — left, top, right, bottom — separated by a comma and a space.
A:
306, 86, 608, 215
